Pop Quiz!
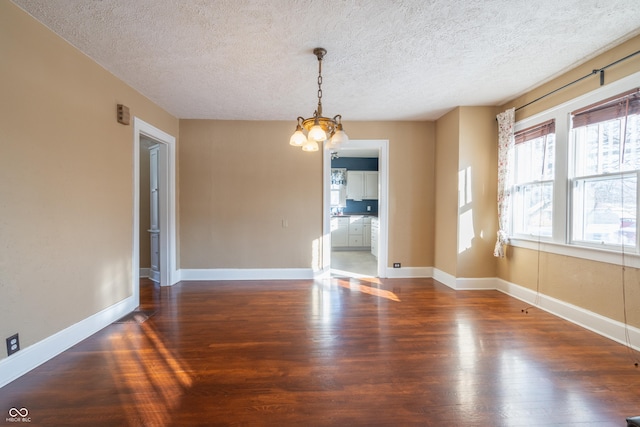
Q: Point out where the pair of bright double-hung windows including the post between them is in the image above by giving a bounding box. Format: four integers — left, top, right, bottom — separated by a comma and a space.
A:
511, 88, 640, 253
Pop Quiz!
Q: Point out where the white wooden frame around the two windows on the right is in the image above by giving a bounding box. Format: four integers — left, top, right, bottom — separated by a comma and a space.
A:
510, 72, 640, 268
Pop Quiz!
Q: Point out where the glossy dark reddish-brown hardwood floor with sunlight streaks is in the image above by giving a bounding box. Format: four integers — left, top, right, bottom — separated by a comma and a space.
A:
0, 279, 640, 426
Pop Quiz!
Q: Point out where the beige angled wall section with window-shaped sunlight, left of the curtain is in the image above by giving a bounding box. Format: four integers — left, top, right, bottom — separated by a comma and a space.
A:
434, 107, 497, 278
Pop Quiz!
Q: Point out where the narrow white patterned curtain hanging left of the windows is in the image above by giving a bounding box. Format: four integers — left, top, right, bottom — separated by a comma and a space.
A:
493, 108, 516, 258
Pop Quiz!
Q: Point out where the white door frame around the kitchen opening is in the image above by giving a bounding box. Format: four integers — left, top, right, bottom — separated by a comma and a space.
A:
322, 139, 389, 278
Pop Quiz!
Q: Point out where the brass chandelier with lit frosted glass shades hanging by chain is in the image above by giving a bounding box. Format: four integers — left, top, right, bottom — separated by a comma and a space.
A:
289, 47, 349, 151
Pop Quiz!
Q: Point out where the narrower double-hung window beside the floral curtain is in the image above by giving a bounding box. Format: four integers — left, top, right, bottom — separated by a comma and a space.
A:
512, 120, 555, 237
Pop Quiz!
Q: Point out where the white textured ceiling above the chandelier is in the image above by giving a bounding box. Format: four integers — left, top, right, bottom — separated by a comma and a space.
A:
13, 0, 640, 120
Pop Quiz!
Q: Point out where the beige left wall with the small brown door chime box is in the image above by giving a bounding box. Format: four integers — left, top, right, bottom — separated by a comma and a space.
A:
0, 1, 178, 358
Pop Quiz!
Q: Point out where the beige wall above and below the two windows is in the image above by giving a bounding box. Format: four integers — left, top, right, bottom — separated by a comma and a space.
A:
497, 37, 640, 327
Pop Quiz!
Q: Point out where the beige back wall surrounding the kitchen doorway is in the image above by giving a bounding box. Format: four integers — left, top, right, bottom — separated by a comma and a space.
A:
179, 120, 434, 269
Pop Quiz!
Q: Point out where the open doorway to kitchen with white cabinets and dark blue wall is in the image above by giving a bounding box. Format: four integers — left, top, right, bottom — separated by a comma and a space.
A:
324, 140, 388, 277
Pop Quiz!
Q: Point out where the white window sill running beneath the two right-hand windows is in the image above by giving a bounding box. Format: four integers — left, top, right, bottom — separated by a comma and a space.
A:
509, 237, 640, 268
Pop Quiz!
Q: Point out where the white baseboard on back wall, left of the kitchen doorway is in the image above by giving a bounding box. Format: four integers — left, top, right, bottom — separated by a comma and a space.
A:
180, 268, 314, 280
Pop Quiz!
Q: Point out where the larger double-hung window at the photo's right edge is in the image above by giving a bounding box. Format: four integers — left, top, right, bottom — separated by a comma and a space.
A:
569, 89, 640, 248
